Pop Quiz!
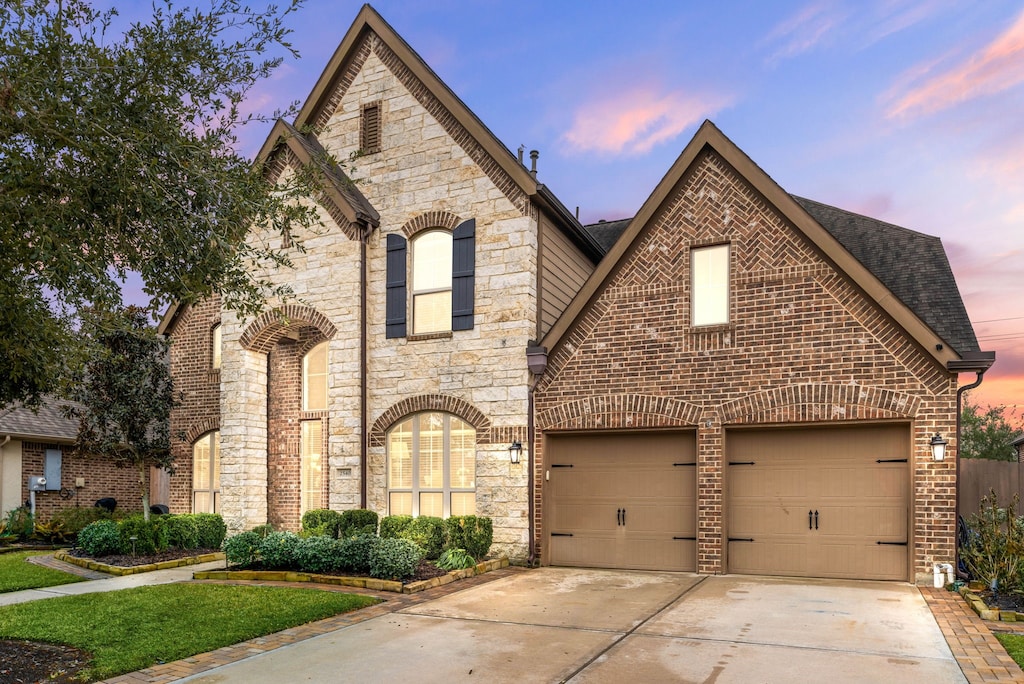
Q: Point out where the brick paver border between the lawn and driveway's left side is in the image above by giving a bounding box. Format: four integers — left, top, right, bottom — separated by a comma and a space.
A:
99, 566, 526, 684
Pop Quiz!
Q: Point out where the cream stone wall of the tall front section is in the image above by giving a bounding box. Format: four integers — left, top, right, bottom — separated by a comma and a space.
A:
221, 29, 537, 557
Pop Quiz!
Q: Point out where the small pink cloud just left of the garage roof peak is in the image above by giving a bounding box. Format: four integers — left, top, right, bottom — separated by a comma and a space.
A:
562, 87, 730, 155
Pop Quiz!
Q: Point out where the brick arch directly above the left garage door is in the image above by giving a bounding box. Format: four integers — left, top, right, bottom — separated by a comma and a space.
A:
537, 394, 703, 430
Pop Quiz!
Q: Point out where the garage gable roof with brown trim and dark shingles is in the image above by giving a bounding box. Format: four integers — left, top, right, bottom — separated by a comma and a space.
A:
541, 121, 992, 371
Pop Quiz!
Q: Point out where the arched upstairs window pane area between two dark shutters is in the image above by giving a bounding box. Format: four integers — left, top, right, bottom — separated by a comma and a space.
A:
412, 230, 452, 335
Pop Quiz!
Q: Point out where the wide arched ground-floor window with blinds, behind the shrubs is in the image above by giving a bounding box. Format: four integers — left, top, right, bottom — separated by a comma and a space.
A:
387, 413, 476, 517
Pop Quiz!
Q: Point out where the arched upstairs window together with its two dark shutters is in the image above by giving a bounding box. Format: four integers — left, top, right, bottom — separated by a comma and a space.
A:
386, 218, 476, 338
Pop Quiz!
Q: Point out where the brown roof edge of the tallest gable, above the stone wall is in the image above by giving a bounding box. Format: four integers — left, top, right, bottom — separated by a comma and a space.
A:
276, 4, 603, 263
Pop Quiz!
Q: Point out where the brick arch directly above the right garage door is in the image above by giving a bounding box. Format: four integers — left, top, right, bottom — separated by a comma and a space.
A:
722, 384, 921, 424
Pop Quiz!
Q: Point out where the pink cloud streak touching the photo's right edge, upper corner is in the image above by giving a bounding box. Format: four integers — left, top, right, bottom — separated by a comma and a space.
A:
887, 11, 1024, 118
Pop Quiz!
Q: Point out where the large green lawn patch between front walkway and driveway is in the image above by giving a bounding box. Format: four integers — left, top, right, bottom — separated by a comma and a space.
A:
0, 584, 378, 680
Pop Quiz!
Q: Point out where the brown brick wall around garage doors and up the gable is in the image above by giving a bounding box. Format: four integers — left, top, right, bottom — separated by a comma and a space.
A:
534, 153, 956, 580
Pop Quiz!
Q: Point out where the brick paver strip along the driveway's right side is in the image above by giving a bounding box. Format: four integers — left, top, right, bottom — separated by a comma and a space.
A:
920, 587, 1024, 684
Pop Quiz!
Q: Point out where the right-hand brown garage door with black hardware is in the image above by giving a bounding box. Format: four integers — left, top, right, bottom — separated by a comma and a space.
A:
726, 426, 910, 580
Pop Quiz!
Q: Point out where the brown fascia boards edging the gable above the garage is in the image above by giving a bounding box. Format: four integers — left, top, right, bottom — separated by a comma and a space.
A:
541, 120, 961, 368
